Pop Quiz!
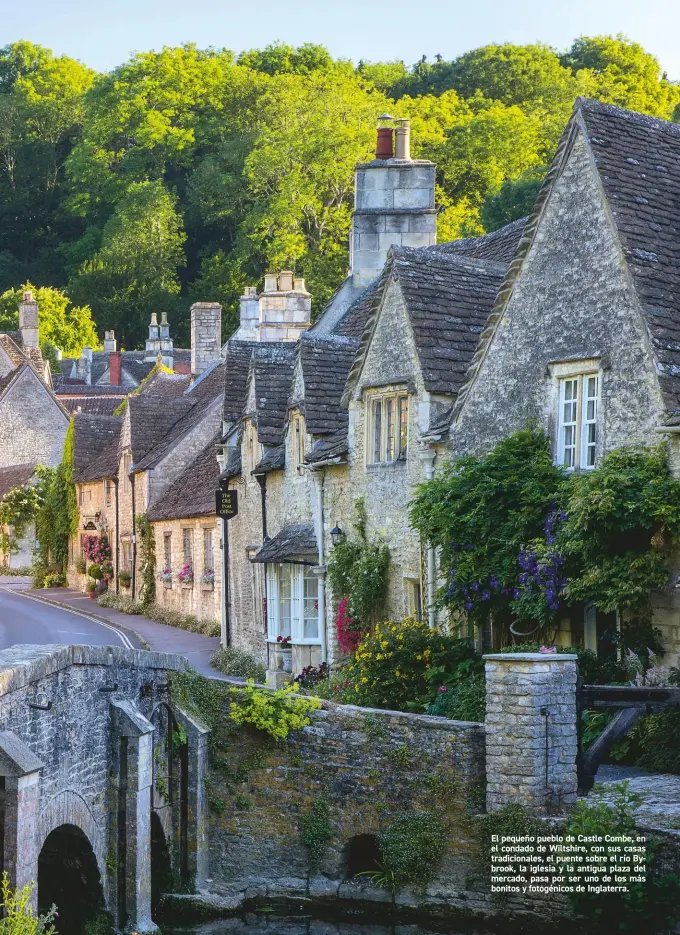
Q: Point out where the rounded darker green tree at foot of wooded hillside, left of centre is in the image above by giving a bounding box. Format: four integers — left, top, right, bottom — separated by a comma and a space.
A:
69, 182, 186, 346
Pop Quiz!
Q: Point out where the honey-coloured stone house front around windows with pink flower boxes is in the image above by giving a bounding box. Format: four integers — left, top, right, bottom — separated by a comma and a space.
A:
153, 516, 222, 620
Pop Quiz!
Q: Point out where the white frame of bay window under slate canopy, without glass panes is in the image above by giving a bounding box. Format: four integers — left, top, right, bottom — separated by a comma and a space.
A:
265, 562, 321, 646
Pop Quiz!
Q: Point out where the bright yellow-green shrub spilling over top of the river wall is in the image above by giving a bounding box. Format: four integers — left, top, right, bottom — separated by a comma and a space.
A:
229, 681, 321, 740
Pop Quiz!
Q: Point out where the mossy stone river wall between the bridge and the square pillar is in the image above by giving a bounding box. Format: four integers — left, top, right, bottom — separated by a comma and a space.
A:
202, 702, 486, 909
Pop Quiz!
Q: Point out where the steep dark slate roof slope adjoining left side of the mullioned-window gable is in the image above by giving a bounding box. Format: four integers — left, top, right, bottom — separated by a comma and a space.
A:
292, 334, 359, 435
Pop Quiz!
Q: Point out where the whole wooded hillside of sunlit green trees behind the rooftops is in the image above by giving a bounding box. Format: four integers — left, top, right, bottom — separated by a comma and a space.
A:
0, 37, 680, 353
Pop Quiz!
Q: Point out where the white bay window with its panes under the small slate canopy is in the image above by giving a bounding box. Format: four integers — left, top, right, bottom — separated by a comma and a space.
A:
267, 563, 320, 643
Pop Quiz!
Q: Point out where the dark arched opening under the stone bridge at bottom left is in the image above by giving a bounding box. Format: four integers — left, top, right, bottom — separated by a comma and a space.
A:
38, 825, 105, 935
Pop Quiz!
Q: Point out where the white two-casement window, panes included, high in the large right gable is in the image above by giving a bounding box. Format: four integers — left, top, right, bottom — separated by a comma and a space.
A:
557, 373, 600, 470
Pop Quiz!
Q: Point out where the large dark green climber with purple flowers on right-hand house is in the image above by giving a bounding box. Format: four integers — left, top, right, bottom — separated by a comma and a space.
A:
411, 428, 680, 653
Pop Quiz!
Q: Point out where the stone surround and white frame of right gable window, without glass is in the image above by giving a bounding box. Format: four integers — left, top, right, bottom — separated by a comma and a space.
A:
548, 357, 604, 472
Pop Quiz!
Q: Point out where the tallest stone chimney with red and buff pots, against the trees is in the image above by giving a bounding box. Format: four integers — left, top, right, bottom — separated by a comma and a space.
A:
350, 114, 437, 286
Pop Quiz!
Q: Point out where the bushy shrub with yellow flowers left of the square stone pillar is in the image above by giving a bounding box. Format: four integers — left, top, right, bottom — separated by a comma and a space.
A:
346, 617, 483, 711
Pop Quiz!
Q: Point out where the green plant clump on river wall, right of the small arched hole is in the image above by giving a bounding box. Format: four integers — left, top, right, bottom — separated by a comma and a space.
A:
378, 812, 447, 893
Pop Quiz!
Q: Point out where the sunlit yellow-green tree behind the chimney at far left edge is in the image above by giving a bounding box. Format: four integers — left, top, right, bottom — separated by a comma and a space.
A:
0, 282, 99, 357
